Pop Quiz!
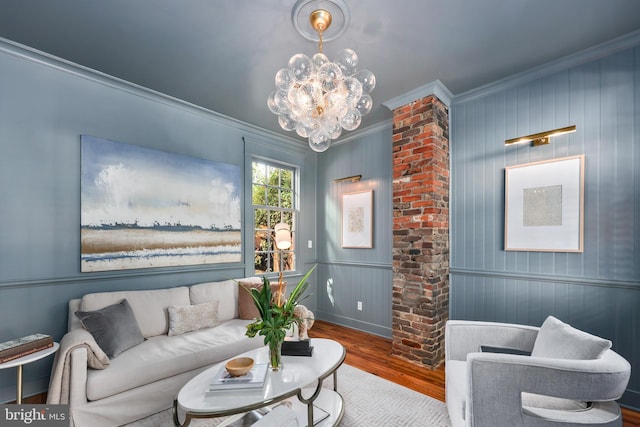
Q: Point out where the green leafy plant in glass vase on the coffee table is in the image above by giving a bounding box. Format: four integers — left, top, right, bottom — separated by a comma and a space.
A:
242, 265, 316, 347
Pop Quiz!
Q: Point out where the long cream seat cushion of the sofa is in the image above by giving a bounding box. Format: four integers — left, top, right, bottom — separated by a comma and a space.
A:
87, 319, 264, 400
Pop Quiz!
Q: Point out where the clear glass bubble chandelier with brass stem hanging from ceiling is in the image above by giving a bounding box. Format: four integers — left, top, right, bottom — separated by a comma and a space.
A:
267, 1, 376, 152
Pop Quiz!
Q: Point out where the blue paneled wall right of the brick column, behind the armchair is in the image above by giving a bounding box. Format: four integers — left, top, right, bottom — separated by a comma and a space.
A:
450, 42, 640, 408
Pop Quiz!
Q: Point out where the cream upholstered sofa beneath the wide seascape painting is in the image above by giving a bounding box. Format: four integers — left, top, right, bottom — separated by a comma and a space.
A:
47, 278, 264, 427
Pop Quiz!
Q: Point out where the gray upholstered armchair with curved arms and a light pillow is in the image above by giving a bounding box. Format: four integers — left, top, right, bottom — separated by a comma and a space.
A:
445, 316, 631, 427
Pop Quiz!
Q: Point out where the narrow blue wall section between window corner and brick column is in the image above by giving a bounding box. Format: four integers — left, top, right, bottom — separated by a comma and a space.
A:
316, 122, 392, 337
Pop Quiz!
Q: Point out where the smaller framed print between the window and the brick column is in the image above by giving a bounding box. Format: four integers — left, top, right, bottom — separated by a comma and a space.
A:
342, 190, 373, 248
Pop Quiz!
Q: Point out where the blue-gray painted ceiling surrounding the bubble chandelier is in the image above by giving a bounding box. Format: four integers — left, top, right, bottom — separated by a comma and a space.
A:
0, 0, 640, 141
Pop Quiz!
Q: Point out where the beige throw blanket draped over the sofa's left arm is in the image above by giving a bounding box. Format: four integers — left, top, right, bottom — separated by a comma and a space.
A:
47, 329, 110, 405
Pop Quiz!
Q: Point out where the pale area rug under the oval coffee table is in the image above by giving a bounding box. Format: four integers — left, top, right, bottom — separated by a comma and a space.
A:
127, 365, 451, 427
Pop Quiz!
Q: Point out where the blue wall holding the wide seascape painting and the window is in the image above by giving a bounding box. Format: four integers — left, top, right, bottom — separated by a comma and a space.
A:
0, 41, 316, 402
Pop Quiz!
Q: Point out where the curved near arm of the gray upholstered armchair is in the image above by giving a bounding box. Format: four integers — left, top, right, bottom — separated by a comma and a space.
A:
466, 350, 631, 426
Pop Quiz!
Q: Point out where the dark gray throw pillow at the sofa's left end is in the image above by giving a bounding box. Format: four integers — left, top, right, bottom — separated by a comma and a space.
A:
75, 299, 144, 359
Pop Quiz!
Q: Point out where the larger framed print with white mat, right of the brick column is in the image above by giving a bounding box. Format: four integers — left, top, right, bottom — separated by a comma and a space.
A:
504, 155, 584, 252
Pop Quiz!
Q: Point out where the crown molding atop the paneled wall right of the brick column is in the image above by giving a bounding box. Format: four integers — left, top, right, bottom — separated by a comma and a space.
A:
453, 30, 640, 104
